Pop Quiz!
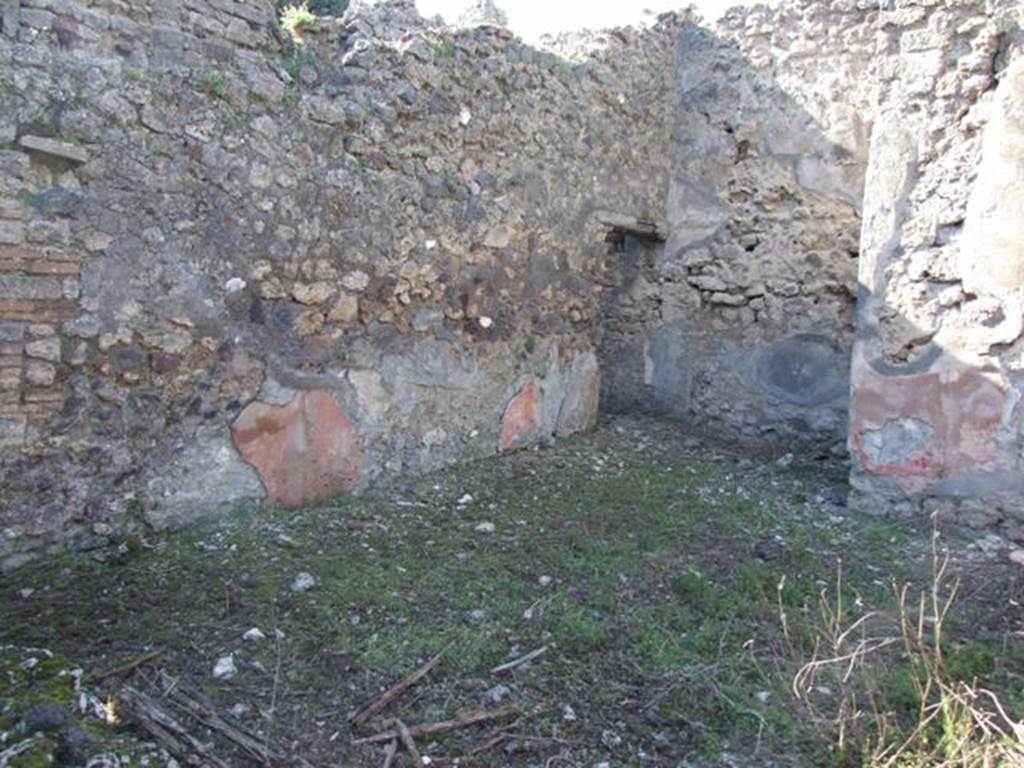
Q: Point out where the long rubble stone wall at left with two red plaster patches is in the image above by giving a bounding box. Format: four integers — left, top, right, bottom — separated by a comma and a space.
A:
0, 0, 680, 565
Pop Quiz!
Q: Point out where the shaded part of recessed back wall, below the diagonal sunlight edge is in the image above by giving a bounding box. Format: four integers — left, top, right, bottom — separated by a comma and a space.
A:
600, 20, 866, 452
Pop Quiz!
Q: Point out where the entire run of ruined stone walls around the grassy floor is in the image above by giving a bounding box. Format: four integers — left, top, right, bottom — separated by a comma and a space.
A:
6, 0, 1024, 567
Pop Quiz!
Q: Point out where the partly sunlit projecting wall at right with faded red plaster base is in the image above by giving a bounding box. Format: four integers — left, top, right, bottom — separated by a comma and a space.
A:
850, 0, 1024, 540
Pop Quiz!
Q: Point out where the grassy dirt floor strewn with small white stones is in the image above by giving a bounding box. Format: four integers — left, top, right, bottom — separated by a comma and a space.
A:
0, 418, 1024, 768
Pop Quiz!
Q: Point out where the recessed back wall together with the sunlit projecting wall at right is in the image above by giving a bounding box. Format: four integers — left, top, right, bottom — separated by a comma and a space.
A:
602, 0, 1024, 542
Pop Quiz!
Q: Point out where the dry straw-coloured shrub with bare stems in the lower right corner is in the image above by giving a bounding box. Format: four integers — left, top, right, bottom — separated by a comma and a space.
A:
779, 532, 1024, 768
